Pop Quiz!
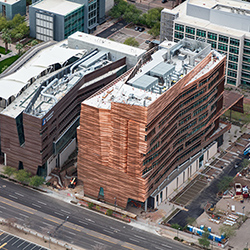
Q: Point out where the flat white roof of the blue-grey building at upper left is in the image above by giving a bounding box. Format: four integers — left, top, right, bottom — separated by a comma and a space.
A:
32, 0, 82, 15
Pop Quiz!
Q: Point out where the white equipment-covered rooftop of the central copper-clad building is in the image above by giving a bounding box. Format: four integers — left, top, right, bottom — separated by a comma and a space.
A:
83, 38, 223, 109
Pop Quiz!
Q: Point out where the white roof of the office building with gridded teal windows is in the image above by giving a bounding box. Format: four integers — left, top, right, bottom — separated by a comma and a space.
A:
163, 0, 250, 37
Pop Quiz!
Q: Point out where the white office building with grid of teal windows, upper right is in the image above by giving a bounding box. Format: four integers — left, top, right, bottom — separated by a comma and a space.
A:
161, 0, 250, 86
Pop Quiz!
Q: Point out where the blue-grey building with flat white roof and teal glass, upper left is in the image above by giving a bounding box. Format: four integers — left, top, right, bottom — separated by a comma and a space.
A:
29, 0, 105, 41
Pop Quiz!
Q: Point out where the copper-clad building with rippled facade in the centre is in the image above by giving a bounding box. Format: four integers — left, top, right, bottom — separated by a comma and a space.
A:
77, 38, 243, 208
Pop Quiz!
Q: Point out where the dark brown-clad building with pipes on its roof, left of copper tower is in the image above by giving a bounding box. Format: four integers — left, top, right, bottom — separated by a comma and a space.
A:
0, 32, 145, 176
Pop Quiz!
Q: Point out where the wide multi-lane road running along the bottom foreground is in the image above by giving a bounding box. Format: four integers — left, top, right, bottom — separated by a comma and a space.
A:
0, 179, 191, 250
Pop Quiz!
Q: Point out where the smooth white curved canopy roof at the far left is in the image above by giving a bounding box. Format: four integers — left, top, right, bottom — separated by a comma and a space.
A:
0, 41, 85, 100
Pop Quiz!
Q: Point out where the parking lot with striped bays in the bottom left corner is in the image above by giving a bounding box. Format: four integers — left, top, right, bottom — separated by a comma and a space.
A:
0, 230, 48, 250
